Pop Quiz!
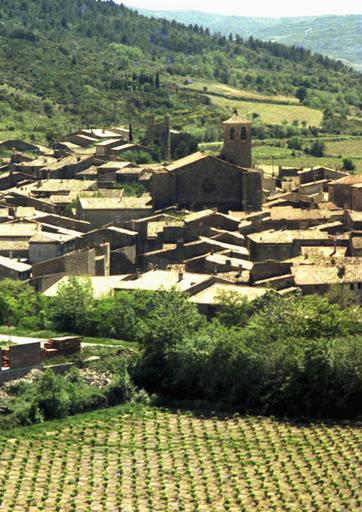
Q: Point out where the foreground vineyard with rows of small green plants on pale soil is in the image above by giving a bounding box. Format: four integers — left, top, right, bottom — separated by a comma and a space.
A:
0, 407, 362, 512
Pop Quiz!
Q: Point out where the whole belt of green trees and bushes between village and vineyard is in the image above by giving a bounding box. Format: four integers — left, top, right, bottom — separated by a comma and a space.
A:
0, 278, 362, 417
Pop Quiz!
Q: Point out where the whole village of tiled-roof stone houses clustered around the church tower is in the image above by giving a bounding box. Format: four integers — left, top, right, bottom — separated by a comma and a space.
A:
0, 112, 362, 314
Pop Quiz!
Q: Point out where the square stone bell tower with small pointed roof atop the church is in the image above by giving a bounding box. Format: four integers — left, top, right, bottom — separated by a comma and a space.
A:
223, 110, 252, 168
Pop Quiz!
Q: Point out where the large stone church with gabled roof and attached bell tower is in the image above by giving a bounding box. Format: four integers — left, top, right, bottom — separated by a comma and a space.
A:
151, 113, 262, 212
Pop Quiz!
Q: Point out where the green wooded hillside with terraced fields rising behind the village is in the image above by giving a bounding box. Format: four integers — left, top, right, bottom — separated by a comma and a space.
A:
0, 0, 362, 142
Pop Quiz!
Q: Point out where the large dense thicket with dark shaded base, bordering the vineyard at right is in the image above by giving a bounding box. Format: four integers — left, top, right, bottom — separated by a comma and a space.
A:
134, 295, 362, 417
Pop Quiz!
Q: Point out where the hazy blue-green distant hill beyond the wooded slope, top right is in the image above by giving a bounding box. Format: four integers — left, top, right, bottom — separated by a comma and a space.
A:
137, 9, 362, 71
